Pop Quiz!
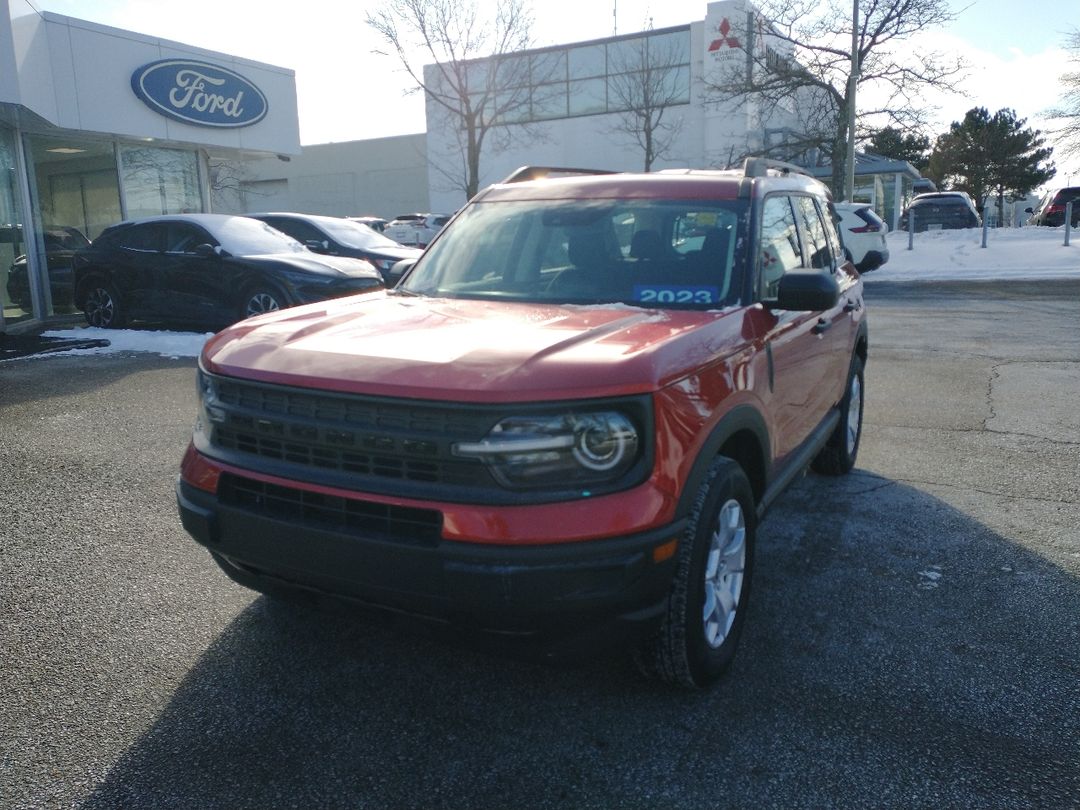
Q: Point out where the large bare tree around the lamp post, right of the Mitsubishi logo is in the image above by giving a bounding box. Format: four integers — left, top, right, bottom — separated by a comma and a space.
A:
713, 0, 963, 195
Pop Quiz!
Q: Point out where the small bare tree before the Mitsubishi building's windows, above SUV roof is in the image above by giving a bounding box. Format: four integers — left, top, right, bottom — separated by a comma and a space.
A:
608, 31, 690, 172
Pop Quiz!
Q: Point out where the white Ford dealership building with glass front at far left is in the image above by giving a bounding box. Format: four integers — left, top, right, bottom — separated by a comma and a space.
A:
0, 0, 300, 328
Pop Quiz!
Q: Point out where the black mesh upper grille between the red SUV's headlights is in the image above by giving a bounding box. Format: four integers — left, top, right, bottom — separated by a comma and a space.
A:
210, 377, 494, 488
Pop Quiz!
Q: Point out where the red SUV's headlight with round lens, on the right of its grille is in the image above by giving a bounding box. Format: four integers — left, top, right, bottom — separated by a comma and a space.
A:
454, 410, 640, 488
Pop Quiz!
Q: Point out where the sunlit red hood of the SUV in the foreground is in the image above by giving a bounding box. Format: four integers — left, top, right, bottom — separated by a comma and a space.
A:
202, 293, 743, 402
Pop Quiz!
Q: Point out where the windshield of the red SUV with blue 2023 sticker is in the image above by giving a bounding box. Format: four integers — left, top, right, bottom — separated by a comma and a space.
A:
397, 200, 746, 309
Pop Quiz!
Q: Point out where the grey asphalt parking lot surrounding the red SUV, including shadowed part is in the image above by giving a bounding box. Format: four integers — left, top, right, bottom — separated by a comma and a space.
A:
0, 278, 1080, 810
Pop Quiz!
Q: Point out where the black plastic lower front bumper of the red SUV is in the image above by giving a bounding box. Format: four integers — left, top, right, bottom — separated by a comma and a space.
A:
176, 480, 684, 635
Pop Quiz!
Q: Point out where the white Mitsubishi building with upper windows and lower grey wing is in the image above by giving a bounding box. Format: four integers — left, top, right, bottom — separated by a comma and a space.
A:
238, 0, 919, 231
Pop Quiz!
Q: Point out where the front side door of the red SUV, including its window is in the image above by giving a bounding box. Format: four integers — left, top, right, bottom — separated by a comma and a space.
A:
757, 193, 842, 464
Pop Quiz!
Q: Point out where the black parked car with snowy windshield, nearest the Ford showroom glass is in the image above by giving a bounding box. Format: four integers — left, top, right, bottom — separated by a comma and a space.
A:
75, 214, 382, 327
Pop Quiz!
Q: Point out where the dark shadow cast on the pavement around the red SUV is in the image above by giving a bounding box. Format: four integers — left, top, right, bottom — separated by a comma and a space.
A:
82, 471, 1080, 810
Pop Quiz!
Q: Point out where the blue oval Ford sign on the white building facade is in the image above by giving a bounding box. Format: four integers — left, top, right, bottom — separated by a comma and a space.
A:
132, 59, 269, 126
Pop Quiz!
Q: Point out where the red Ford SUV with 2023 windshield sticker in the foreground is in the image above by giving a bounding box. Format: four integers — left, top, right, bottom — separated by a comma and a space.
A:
177, 160, 867, 686
